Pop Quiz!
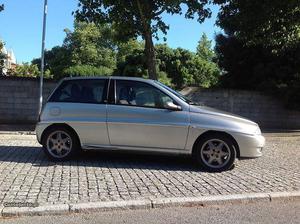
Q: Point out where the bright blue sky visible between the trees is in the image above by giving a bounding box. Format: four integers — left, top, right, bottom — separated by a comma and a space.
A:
0, 0, 221, 63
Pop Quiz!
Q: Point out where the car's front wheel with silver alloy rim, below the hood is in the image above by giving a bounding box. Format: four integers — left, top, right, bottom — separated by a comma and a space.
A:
193, 133, 236, 172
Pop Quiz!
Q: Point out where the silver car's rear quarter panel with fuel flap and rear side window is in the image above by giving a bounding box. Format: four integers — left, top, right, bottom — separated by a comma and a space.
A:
47, 79, 110, 147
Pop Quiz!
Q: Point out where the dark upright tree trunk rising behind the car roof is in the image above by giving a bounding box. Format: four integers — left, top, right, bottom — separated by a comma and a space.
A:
144, 31, 157, 80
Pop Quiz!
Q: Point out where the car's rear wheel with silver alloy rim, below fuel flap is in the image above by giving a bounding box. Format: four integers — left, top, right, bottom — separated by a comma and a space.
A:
42, 126, 80, 162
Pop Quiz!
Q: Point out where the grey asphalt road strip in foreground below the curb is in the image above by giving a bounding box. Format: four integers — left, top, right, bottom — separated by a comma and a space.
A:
0, 201, 300, 224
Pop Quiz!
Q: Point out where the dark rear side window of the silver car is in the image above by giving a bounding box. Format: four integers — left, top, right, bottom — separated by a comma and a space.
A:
49, 79, 107, 103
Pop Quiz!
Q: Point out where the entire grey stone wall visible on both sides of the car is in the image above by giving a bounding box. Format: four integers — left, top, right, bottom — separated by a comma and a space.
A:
0, 77, 300, 129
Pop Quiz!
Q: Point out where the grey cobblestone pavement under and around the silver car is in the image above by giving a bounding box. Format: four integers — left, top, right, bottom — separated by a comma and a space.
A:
0, 135, 300, 206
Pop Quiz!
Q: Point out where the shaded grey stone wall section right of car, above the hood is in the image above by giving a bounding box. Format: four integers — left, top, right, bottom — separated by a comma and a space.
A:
182, 88, 300, 129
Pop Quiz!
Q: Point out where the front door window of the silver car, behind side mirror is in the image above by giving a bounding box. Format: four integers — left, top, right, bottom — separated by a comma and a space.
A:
116, 80, 173, 108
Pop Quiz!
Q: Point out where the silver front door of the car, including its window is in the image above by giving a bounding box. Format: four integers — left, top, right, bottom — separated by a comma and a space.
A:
107, 80, 189, 149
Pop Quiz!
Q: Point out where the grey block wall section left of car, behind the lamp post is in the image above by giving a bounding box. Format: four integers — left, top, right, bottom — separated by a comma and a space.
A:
0, 77, 56, 124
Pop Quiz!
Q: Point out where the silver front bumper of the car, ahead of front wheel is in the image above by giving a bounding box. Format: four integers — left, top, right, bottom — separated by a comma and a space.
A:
233, 134, 265, 158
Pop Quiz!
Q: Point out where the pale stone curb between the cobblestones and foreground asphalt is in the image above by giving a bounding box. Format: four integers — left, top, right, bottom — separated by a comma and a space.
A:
0, 191, 300, 217
